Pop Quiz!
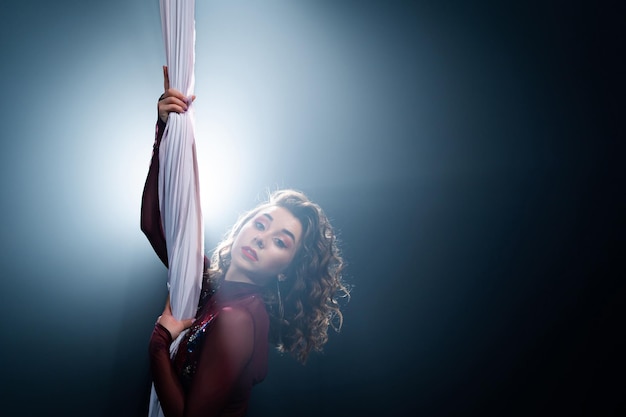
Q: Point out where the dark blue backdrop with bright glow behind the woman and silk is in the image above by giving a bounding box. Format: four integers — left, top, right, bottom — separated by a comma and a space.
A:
0, 0, 626, 416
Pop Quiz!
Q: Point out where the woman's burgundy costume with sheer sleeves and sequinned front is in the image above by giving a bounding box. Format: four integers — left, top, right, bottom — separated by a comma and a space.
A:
141, 120, 269, 417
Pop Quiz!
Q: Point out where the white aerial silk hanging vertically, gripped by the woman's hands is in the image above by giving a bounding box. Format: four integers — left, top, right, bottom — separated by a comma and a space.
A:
149, 0, 204, 417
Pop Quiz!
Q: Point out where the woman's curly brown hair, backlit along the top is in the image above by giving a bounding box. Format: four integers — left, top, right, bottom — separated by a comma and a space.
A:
208, 189, 350, 363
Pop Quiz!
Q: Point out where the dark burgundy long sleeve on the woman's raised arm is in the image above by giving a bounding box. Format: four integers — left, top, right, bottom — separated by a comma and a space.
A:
141, 119, 168, 267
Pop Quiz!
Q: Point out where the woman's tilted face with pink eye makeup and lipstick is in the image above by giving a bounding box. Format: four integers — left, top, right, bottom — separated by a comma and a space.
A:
226, 206, 302, 285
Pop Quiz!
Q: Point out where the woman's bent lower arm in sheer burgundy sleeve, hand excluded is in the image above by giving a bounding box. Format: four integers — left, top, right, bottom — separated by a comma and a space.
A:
150, 308, 254, 417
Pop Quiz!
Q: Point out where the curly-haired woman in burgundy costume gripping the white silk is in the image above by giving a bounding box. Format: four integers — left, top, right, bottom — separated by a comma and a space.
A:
141, 72, 348, 417
